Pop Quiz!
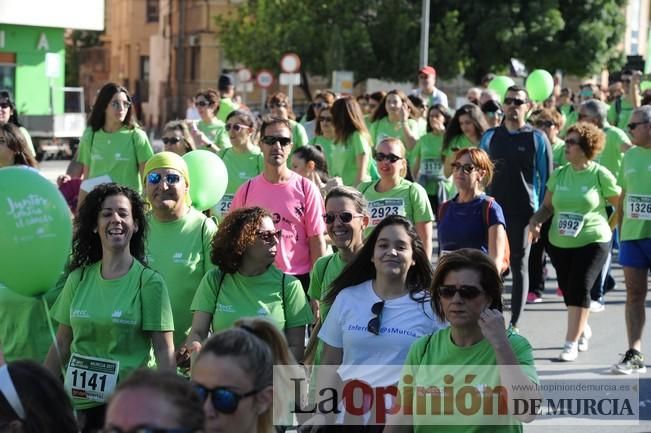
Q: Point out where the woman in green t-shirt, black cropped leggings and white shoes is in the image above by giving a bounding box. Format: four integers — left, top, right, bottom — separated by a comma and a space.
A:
529, 122, 621, 361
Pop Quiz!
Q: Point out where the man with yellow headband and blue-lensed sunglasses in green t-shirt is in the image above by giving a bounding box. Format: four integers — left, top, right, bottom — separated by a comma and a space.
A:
143, 152, 217, 347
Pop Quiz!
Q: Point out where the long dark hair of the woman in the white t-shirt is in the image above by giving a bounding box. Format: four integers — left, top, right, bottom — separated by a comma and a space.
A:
325, 215, 433, 304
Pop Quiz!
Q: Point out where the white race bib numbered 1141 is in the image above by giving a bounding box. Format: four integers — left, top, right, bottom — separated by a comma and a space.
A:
64, 353, 120, 402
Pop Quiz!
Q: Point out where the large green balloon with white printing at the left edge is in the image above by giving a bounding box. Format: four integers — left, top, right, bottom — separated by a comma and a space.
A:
0, 166, 72, 296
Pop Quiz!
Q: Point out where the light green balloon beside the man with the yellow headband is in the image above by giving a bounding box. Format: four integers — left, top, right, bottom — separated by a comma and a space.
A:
183, 150, 228, 212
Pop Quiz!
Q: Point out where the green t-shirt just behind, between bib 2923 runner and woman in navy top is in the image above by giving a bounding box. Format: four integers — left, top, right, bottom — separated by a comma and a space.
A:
413, 134, 450, 195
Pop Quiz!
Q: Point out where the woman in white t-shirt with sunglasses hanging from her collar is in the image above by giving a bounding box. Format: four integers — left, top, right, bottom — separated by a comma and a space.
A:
316, 215, 443, 432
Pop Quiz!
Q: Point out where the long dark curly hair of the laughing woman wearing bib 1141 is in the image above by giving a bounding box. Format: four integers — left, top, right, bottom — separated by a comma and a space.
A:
68, 183, 148, 272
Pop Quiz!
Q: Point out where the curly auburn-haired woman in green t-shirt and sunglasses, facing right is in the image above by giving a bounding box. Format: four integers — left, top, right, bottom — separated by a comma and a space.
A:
179, 207, 312, 360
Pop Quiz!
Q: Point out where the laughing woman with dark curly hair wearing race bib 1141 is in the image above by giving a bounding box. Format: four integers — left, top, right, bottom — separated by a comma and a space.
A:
45, 183, 176, 432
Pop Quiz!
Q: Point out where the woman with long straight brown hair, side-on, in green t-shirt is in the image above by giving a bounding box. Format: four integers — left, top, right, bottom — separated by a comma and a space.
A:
329, 96, 374, 186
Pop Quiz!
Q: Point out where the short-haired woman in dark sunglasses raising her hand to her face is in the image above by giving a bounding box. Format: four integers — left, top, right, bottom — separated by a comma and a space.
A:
385, 249, 540, 433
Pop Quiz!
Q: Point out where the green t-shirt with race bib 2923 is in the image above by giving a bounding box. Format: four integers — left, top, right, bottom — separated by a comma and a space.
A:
357, 179, 434, 236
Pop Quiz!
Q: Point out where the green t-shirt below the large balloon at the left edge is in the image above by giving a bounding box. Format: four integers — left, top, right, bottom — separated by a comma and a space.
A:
0, 284, 63, 363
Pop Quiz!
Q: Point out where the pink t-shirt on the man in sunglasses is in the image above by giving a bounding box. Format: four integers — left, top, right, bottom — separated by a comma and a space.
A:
231, 172, 325, 275
